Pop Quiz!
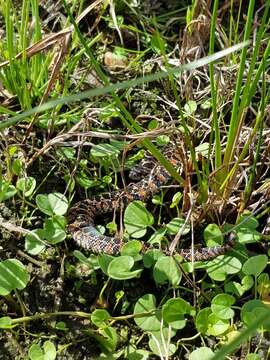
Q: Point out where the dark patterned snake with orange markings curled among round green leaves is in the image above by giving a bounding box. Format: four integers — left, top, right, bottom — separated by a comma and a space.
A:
68, 146, 235, 261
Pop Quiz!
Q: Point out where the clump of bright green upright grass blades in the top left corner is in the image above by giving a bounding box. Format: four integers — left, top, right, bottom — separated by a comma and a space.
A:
0, 0, 47, 110
